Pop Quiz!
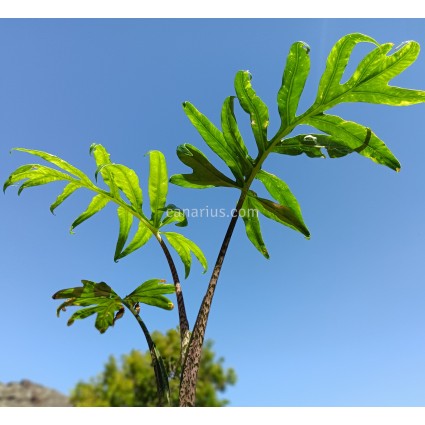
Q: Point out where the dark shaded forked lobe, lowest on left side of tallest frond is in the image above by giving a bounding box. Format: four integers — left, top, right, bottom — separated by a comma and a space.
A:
170, 143, 239, 189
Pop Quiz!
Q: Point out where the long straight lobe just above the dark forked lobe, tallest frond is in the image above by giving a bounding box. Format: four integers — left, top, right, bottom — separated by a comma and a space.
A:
183, 102, 244, 184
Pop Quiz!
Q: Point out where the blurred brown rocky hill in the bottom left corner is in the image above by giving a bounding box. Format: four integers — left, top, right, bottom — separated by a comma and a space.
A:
0, 379, 72, 407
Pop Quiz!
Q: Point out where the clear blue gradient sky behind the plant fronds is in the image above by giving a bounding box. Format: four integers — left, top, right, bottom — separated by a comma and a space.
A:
0, 19, 425, 406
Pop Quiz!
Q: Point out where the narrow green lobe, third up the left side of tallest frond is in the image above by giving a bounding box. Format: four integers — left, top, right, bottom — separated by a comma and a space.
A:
221, 96, 252, 176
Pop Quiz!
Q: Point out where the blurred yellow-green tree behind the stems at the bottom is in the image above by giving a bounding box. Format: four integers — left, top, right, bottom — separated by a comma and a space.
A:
71, 329, 236, 407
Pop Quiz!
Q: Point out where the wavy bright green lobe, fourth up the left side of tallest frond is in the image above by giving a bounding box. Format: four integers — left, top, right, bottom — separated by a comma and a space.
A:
235, 71, 269, 154
